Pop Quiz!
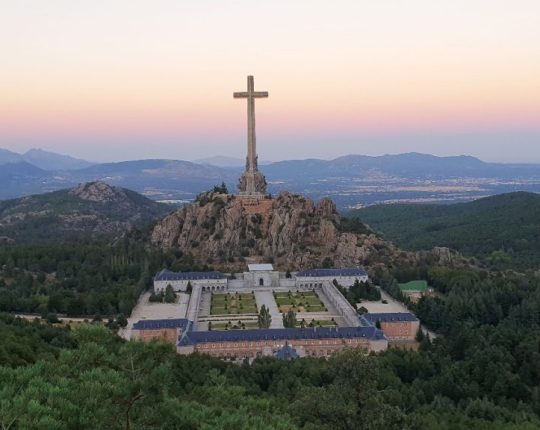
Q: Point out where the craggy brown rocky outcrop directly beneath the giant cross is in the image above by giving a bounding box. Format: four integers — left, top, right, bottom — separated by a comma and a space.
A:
151, 193, 460, 270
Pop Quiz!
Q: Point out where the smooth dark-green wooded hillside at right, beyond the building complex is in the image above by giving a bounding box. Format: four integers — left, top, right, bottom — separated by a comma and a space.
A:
350, 192, 540, 269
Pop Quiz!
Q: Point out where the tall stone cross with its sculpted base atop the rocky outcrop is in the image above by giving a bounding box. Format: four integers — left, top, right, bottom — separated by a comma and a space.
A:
233, 76, 268, 197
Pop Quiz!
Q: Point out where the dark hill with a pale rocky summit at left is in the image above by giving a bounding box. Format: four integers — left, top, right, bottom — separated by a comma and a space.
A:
0, 182, 172, 242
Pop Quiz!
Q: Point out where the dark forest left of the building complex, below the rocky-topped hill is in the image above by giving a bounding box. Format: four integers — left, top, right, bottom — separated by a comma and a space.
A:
0, 236, 208, 318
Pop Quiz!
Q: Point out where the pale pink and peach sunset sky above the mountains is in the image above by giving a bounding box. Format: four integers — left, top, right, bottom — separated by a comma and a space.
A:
0, 0, 540, 163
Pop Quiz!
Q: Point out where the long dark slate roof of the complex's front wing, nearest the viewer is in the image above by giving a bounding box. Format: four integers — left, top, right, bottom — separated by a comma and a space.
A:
179, 325, 385, 346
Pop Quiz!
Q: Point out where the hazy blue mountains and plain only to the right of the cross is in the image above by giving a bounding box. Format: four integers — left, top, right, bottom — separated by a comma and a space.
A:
262, 153, 540, 209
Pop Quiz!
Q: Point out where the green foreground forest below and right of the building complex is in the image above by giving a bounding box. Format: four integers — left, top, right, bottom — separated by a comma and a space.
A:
0, 257, 540, 430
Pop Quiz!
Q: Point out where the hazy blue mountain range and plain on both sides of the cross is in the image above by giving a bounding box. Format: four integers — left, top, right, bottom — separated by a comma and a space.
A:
0, 150, 540, 209
